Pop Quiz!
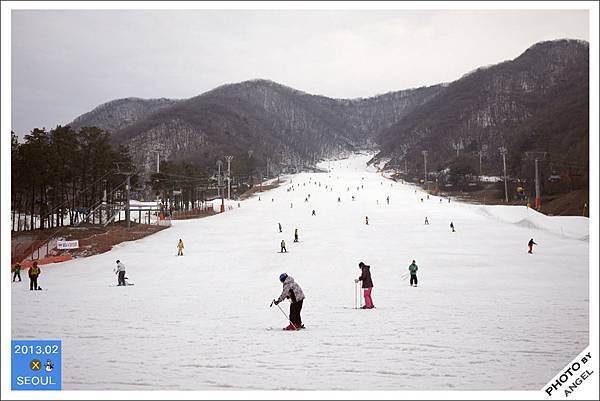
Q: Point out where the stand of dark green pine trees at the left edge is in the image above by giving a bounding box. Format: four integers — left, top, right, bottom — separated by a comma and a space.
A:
11, 126, 135, 231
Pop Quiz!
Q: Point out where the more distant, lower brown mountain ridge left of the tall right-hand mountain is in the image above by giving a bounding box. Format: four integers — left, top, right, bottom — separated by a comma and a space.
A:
71, 80, 441, 170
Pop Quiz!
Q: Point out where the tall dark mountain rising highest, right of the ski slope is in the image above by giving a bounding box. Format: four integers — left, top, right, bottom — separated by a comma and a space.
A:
375, 40, 589, 175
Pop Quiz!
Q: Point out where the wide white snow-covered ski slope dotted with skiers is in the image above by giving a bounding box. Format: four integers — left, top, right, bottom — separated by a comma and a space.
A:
12, 155, 589, 390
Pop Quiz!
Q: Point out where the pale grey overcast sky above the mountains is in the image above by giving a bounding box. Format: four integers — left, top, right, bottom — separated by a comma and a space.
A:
11, 10, 589, 136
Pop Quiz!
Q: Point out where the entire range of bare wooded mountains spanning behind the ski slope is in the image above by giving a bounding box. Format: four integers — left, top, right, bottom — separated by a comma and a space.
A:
71, 40, 589, 184
